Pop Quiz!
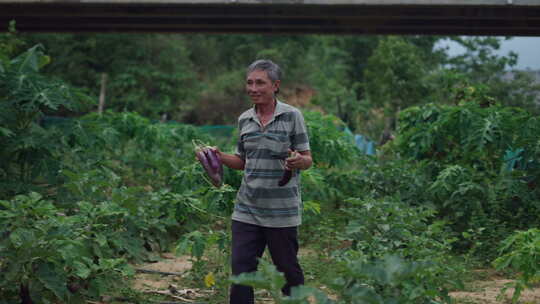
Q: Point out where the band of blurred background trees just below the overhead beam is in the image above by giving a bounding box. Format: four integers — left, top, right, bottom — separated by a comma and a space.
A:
16, 34, 538, 129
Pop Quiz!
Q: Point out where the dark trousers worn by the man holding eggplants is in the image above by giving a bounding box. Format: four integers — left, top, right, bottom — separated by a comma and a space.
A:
230, 221, 304, 304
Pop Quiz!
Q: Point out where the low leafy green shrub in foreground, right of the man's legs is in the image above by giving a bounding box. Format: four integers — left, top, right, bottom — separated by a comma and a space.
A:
339, 198, 462, 303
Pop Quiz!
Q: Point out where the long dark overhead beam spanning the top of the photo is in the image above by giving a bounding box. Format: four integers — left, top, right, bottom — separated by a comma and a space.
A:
0, 0, 540, 36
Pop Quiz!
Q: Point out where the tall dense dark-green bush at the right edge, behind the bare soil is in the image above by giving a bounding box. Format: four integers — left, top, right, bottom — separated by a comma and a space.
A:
389, 95, 540, 259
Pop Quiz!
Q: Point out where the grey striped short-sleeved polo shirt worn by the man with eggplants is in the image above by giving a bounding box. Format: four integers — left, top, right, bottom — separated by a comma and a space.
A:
232, 101, 309, 227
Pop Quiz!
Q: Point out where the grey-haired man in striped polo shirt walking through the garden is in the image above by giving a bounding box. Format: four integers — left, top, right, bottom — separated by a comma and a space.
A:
212, 60, 312, 304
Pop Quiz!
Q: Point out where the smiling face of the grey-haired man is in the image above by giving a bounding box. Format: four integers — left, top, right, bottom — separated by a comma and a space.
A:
246, 70, 279, 104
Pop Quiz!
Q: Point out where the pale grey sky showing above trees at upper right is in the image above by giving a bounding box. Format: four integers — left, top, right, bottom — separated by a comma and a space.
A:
442, 37, 540, 70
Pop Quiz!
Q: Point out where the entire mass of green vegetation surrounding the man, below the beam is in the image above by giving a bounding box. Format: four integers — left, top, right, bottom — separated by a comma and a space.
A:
4, 32, 540, 304
